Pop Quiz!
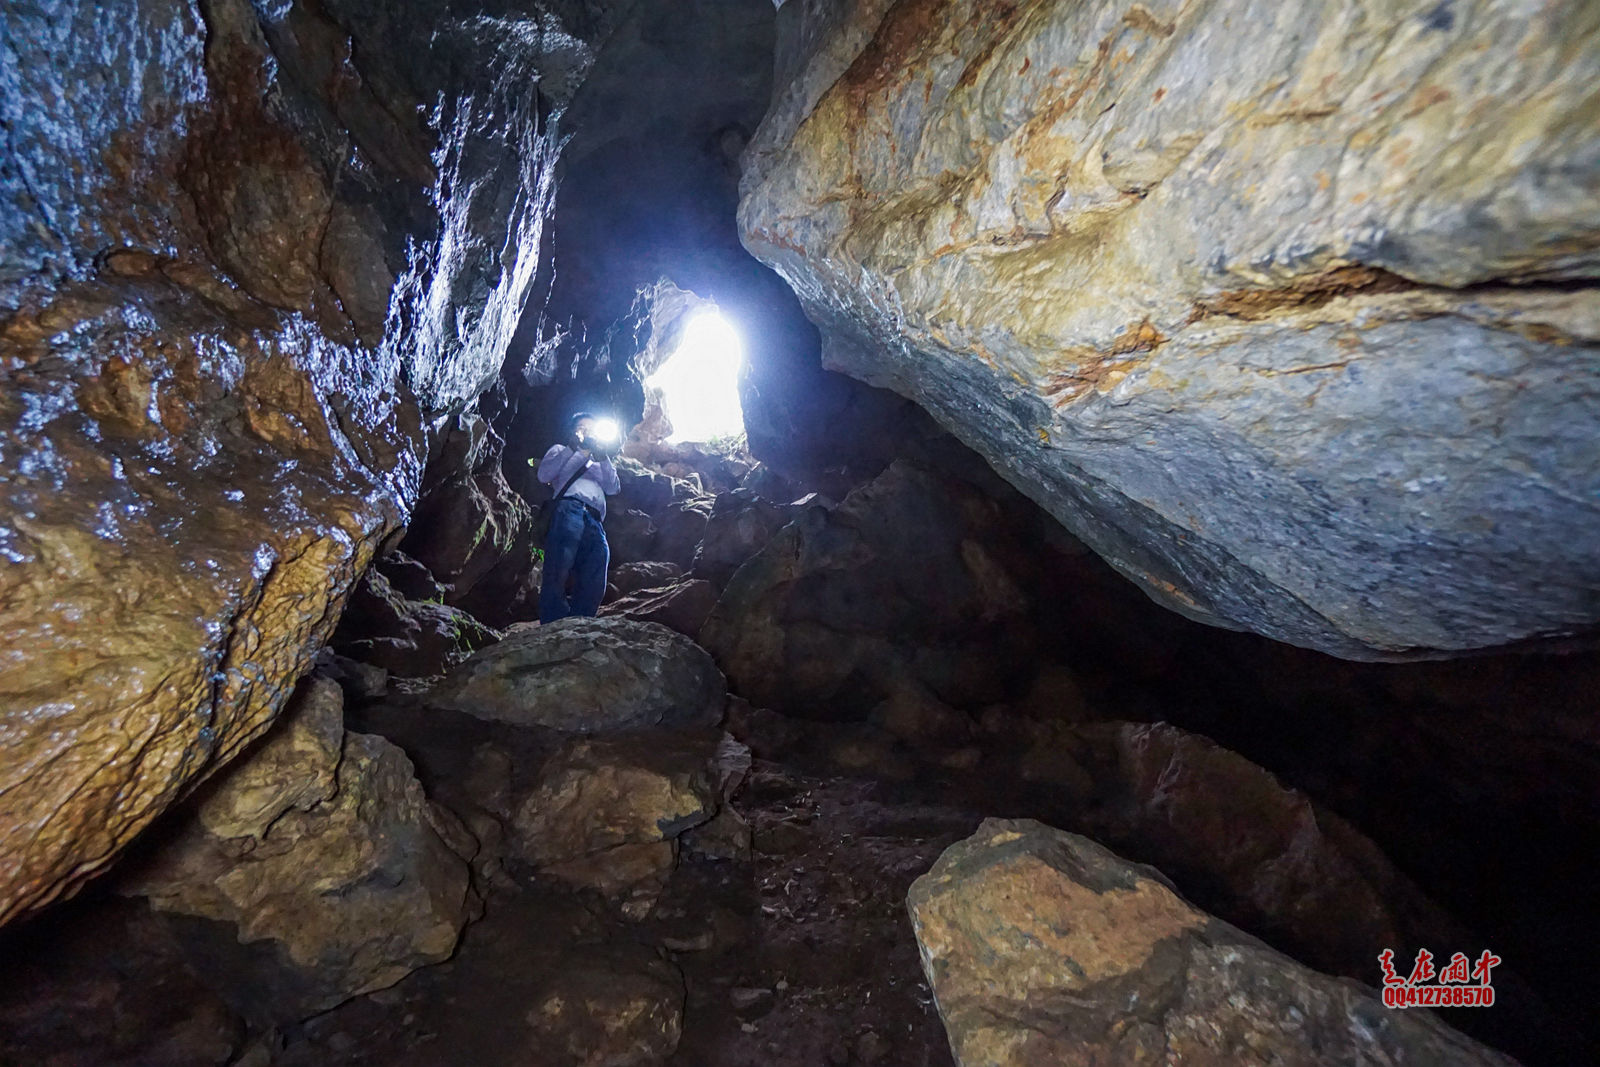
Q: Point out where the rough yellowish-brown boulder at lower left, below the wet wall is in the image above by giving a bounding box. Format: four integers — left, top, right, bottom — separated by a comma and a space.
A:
118, 678, 477, 1021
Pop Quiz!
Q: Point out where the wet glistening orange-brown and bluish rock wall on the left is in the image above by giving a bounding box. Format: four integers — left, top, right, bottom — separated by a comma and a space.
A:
0, 0, 584, 921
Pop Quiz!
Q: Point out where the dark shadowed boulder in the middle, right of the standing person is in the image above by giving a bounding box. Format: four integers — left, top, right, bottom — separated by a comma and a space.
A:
699, 462, 1030, 718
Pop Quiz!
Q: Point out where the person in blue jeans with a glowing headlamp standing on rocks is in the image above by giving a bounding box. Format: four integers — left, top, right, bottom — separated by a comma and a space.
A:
530, 411, 622, 624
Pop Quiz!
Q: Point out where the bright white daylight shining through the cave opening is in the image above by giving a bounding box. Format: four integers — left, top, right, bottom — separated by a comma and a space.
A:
645, 309, 744, 442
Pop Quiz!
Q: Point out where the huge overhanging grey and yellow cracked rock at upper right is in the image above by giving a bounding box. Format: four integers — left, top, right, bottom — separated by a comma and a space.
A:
739, 0, 1600, 657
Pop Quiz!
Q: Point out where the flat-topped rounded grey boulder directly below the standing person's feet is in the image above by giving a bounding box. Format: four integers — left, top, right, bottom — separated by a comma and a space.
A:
427, 616, 726, 733
